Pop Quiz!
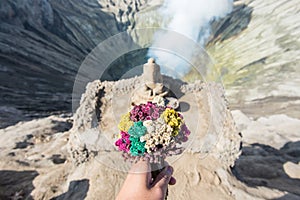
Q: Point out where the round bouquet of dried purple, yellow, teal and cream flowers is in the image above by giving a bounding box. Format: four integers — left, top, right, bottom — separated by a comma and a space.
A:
115, 96, 190, 198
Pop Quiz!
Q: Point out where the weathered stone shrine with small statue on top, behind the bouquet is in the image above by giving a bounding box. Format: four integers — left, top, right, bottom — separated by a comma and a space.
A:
68, 58, 241, 199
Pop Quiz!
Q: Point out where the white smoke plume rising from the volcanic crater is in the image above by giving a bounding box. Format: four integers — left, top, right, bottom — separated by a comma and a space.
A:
148, 0, 233, 76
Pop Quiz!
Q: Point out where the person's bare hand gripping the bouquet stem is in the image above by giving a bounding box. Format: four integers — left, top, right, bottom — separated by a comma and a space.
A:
116, 161, 176, 200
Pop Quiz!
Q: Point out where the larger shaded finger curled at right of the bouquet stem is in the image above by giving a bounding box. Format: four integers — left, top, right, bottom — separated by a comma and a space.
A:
153, 166, 173, 193
